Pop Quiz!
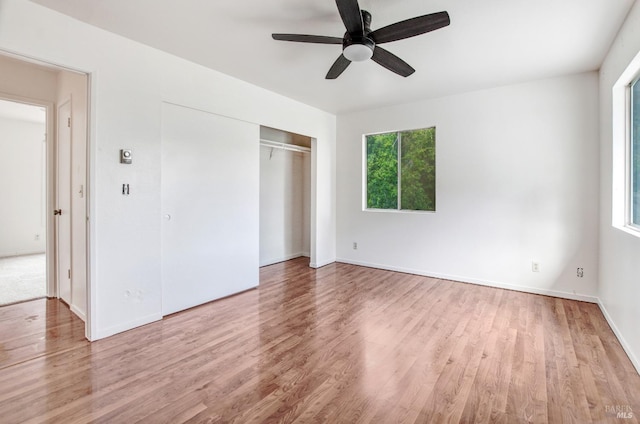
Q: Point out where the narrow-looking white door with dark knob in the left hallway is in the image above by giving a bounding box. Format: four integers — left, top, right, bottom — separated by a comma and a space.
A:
55, 101, 71, 305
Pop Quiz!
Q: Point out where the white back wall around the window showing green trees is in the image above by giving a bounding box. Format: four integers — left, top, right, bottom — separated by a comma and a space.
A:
336, 73, 598, 301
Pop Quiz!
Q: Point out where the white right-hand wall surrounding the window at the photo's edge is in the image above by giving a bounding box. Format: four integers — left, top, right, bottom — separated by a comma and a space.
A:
598, 2, 640, 372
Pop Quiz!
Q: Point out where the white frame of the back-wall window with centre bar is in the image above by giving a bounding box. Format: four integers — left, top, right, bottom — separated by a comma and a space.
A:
362, 125, 438, 214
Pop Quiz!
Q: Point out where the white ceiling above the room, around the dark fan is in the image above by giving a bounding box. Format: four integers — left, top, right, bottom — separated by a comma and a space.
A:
32, 0, 634, 113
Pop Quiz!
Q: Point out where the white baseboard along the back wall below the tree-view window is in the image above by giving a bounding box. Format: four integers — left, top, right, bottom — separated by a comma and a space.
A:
336, 258, 598, 303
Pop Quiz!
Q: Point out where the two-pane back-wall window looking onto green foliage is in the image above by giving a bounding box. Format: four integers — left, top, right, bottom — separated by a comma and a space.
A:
365, 127, 436, 211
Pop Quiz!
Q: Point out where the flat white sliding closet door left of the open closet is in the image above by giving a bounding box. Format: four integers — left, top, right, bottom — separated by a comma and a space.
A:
162, 104, 259, 315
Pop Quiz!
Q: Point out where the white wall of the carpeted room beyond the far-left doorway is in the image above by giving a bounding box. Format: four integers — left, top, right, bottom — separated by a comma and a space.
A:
0, 117, 46, 257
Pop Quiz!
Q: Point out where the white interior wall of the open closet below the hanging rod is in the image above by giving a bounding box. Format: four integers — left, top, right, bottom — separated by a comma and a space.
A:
260, 146, 311, 266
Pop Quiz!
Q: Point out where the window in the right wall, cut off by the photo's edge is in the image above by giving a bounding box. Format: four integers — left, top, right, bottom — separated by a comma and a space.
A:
629, 78, 640, 227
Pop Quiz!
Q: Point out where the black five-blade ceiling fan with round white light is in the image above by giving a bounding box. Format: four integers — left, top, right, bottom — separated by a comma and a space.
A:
271, 0, 450, 79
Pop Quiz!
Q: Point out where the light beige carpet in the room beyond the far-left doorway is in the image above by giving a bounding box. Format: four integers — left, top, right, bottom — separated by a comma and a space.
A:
0, 253, 47, 305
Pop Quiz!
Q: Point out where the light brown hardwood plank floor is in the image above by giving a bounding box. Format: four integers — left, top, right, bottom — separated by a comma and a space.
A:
0, 259, 640, 423
